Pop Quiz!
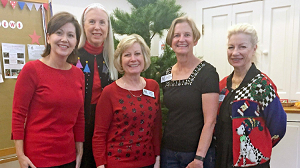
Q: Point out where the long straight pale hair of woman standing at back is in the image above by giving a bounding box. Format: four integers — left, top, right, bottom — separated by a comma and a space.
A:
79, 3, 118, 80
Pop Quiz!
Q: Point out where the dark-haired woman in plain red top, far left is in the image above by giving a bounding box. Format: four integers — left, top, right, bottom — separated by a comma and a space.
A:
12, 12, 84, 168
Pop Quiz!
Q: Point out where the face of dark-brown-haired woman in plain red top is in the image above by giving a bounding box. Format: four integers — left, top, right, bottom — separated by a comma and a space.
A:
47, 23, 77, 57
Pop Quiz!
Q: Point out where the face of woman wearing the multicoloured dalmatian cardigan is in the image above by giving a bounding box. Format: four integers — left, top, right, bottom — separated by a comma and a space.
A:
227, 33, 257, 69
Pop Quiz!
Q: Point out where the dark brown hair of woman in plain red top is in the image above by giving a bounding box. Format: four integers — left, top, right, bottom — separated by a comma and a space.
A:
42, 12, 81, 64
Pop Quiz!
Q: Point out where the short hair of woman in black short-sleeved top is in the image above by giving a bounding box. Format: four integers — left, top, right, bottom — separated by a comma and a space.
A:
166, 16, 201, 47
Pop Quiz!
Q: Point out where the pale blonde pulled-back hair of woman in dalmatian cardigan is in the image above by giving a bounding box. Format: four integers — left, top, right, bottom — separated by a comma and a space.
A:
227, 23, 259, 62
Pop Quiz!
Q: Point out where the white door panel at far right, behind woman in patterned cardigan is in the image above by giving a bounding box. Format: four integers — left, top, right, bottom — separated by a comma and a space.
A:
261, 0, 299, 98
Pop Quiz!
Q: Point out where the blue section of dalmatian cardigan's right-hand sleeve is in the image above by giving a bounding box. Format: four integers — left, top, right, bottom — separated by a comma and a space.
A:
263, 83, 287, 147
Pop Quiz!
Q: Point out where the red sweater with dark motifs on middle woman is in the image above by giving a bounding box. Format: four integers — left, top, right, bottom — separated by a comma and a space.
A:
93, 79, 161, 168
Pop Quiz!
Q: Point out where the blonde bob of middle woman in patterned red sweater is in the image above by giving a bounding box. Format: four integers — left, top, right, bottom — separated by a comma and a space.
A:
114, 34, 151, 74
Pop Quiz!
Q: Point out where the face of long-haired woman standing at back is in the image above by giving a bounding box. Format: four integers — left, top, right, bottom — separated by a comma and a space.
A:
84, 8, 108, 47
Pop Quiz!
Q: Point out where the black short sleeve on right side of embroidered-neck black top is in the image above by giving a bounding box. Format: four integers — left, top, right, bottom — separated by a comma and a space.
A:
200, 64, 219, 94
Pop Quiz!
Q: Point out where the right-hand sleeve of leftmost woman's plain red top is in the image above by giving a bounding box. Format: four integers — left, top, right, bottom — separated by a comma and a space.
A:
74, 70, 85, 142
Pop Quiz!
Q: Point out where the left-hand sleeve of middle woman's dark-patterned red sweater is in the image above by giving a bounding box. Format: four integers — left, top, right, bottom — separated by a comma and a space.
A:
92, 84, 113, 167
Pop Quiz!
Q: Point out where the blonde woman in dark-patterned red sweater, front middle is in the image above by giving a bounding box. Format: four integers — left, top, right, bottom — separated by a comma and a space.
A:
93, 34, 161, 168
